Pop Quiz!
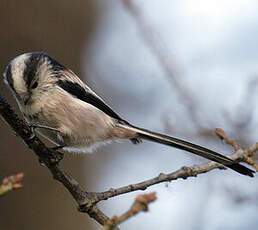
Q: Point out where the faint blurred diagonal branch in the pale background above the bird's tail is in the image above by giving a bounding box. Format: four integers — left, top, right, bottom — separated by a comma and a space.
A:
121, 0, 203, 129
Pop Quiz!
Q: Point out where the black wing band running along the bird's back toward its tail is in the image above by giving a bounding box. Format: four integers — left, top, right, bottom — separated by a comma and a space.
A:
57, 80, 122, 121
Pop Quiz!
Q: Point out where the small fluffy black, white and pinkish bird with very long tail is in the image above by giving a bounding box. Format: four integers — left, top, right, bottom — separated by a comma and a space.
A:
3, 52, 254, 177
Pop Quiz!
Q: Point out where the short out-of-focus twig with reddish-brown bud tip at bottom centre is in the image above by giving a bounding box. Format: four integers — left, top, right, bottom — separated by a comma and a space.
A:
103, 192, 157, 230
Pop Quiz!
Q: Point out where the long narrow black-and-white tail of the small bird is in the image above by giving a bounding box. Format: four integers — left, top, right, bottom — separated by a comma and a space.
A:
122, 124, 255, 177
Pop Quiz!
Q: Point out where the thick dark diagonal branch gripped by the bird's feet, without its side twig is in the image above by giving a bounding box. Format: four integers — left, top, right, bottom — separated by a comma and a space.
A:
0, 96, 109, 225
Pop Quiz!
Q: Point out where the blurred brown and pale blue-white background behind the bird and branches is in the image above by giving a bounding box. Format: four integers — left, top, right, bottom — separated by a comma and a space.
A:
0, 0, 258, 230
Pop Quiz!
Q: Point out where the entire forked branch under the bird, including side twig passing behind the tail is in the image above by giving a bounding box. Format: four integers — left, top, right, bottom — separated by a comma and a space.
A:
0, 93, 258, 228
